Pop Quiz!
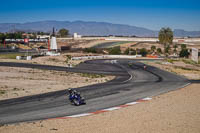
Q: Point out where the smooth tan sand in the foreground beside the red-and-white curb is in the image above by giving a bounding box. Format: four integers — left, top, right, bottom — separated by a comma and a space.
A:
0, 84, 200, 133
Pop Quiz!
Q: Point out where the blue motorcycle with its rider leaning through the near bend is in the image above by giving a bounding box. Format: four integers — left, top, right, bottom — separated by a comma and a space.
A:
68, 89, 86, 106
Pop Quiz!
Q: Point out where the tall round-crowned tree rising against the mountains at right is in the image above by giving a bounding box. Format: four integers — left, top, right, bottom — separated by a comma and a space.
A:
159, 28, 174, 45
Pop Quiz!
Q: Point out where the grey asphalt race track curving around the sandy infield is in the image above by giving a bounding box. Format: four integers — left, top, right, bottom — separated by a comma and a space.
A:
0, 59, 190, 124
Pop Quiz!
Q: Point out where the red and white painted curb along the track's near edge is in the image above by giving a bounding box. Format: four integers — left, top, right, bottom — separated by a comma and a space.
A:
47, 97, 152, 120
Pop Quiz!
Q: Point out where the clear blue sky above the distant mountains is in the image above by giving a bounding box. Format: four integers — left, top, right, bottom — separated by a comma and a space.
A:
0, 0, 200, 31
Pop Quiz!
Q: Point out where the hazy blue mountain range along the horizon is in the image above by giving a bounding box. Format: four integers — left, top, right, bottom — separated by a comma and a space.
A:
0, 21, 200, 37
